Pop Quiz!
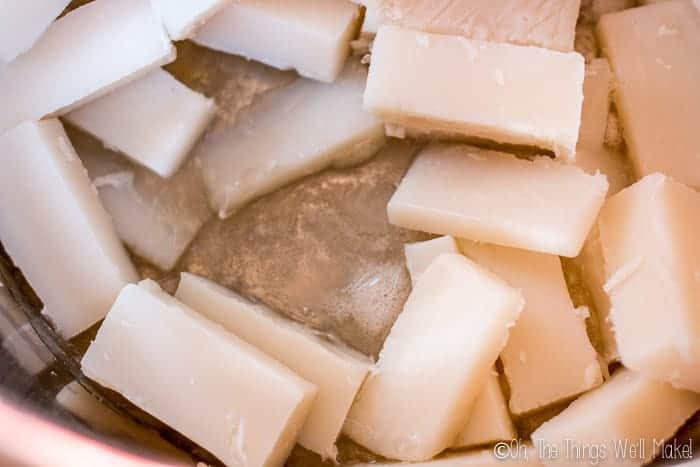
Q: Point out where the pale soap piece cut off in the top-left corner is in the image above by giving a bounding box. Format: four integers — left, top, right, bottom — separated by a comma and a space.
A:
0, 0, 70, 62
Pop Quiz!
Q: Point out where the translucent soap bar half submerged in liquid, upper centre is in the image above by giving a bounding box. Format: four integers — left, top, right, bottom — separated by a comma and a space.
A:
196, 69, 384, 218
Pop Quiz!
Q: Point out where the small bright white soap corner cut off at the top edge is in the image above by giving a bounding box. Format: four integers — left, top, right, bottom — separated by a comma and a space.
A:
151, 0, 230, 41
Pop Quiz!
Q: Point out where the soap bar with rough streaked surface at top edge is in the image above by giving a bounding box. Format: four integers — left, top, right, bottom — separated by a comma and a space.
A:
379, 0, 581, 52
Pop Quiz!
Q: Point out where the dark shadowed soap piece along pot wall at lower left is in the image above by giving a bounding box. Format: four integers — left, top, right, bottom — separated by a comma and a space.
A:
56, 381, 192, 465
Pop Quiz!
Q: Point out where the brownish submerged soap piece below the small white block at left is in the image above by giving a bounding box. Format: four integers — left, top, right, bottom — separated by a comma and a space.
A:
69, 131, 212, 271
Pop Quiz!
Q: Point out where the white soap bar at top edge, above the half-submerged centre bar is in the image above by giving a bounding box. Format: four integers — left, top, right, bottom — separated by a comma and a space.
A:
193, 0, 360, 82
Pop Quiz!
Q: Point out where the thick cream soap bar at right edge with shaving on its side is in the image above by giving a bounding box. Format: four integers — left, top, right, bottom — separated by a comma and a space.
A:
598, 174, 700, 392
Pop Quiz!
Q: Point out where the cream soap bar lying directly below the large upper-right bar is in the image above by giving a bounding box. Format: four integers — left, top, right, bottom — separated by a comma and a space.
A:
387, 144, 608, 257
